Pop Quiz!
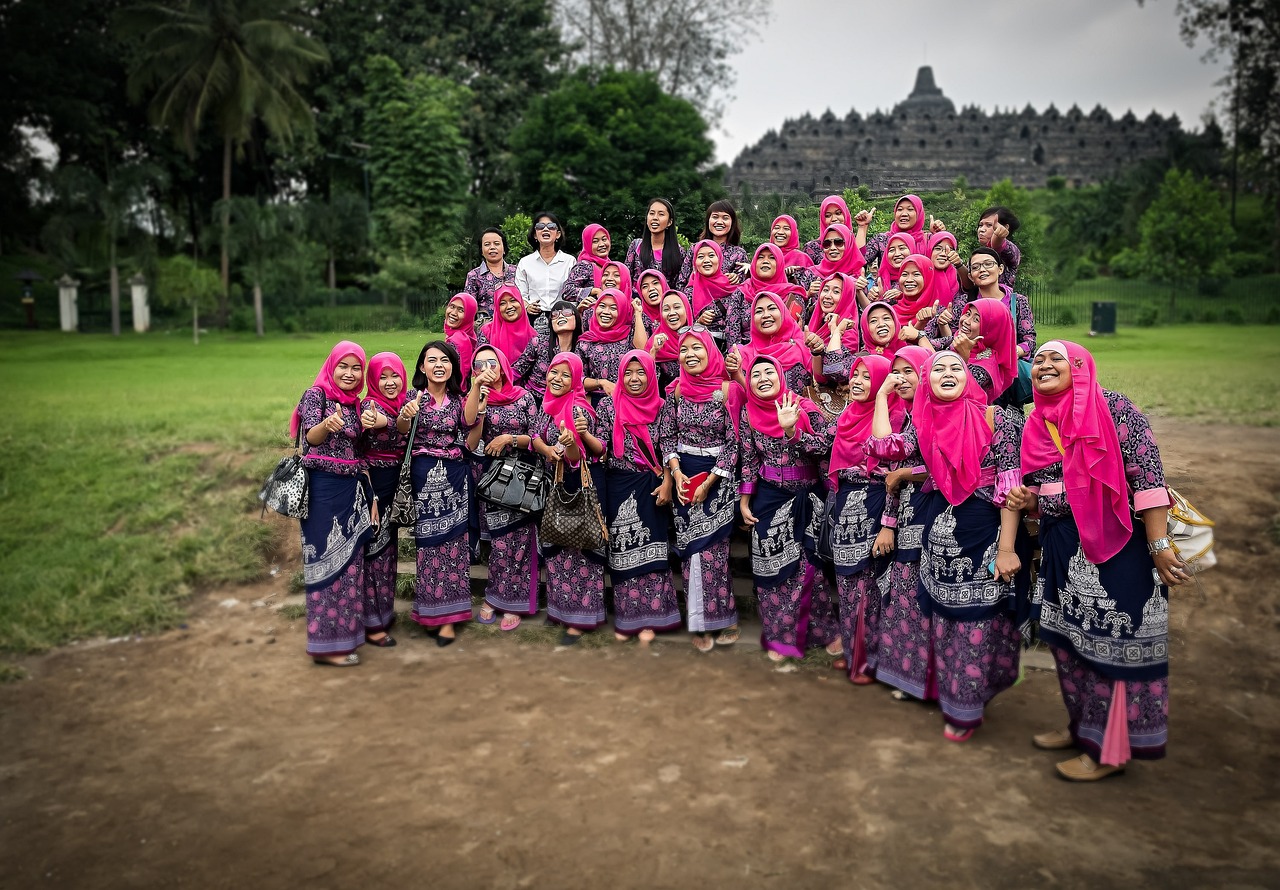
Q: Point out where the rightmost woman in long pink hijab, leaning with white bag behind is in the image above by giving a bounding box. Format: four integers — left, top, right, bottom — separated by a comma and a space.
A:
1009, 341, 1190, 781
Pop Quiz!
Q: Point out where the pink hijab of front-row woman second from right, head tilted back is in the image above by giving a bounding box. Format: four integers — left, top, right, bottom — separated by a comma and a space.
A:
911, 350, 992, 506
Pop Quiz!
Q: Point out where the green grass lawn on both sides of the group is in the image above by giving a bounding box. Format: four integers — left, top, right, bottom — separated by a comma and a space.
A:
0, 325, 1280, 652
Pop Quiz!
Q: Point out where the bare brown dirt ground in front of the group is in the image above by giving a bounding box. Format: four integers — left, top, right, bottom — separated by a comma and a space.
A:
0, 421, 1280, 890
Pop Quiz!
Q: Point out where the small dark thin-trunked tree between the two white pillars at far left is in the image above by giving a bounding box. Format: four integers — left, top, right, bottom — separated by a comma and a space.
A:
45, 161, 165, 337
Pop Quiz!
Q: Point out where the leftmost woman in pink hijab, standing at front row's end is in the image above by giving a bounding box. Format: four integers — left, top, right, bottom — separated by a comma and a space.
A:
289, 339, 378, 667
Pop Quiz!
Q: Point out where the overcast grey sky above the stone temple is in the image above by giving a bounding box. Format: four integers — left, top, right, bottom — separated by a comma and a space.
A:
713, 0, 1221, 163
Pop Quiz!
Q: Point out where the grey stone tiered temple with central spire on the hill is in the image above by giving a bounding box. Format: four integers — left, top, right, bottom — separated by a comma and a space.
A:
726, 65, 1181, 195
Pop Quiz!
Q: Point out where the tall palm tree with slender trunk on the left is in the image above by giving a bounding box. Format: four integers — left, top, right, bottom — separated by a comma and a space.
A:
118, 0, 329, 323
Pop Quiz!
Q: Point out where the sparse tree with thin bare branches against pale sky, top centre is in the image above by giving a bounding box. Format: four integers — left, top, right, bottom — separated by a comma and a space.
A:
557, 0, 769, 120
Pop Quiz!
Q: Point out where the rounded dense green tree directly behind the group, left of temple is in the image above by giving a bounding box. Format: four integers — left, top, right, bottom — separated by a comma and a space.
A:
511, 68, 724, 243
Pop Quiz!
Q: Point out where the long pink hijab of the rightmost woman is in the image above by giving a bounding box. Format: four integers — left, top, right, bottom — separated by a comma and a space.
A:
1021, 341, 1133, 565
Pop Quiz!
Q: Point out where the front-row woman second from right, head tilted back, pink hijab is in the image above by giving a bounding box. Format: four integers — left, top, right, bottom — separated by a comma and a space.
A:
896, 352, 1030, 741
